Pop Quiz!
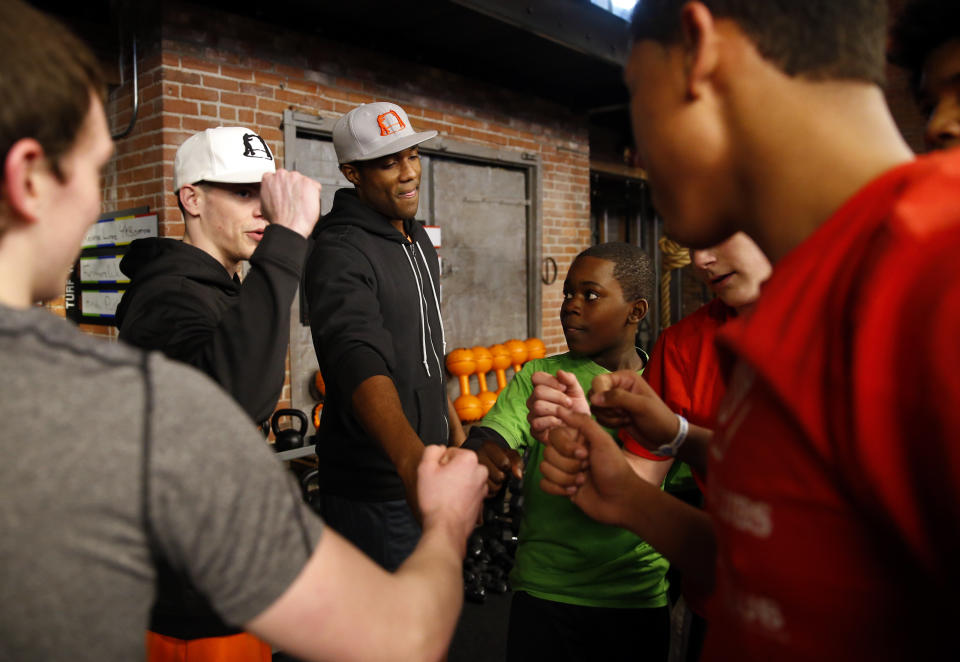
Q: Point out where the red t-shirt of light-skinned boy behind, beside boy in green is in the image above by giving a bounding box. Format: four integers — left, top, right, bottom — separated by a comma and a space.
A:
620, 299, 734, 466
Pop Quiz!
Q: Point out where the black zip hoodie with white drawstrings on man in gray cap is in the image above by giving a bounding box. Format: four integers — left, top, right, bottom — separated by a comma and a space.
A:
304, 189, 449, 501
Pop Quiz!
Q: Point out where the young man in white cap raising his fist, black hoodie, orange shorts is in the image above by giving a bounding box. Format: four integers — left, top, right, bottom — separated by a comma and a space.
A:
116, 127, 320, 662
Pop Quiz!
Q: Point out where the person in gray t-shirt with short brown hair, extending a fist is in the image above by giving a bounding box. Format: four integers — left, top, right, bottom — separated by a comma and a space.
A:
0, 0, 486, 661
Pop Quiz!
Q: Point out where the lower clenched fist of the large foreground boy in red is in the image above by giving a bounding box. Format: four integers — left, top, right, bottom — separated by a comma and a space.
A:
540, 408, 641, 526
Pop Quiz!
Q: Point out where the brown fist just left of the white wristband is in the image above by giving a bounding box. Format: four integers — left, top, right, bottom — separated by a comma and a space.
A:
589, 370, 679, 450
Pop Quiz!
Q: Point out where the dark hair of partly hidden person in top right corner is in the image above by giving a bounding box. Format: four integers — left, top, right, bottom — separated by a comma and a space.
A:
887, 0, 960, 98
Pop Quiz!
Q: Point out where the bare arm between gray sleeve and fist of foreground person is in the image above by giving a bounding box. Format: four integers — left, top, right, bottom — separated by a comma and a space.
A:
251, 525, 464, 662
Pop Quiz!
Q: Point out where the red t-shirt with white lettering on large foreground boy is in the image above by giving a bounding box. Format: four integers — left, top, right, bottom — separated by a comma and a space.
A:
704, 150, 960, 662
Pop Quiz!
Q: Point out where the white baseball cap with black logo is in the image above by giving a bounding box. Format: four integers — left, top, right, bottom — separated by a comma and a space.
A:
173, 126, 277, 191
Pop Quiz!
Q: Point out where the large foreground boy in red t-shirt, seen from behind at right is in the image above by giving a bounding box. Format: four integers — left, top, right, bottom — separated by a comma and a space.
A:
541, 0, 960, 662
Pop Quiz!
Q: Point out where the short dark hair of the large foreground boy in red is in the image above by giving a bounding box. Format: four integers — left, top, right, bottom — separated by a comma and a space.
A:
630, 0, 887, 85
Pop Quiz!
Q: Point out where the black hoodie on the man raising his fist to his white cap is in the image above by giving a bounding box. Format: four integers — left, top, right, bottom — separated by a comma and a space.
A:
116, 225, 307, 422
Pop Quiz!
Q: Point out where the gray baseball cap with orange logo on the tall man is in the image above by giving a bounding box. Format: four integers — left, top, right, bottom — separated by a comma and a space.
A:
333, 101, 437, 163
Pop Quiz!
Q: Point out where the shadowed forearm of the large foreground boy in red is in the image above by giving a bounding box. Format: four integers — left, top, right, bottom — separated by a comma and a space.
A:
620, 477, 717, 593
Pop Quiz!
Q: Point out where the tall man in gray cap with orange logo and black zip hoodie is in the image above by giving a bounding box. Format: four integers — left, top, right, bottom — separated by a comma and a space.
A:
305, 102, 463, 569
